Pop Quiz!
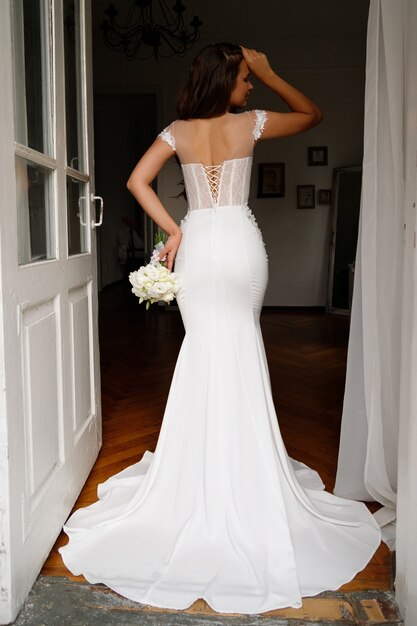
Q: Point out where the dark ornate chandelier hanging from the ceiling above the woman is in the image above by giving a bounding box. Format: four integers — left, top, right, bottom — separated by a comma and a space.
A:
100, 0, 202, 60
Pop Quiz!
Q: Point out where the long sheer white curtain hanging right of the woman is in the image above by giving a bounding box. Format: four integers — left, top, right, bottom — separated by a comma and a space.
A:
334, 0, 407, 549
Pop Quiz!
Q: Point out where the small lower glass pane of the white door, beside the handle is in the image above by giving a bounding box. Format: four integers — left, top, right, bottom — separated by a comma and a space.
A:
67, 176, 89, 255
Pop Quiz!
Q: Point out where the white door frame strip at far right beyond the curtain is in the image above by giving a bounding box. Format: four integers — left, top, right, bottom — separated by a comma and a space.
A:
395, 0, 417, 626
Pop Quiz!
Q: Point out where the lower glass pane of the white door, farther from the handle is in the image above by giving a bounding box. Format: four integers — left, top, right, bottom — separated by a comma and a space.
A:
16, 157, 55, 265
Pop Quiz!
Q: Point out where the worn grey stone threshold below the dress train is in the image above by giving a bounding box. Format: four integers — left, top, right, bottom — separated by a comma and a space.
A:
13, 576, 403, 626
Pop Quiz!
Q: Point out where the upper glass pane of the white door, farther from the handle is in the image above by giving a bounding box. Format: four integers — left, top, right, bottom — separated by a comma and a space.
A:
11, 0, 52, 154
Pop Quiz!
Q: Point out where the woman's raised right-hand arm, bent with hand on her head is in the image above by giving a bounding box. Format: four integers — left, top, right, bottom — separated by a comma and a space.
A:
241, 46, 323, 139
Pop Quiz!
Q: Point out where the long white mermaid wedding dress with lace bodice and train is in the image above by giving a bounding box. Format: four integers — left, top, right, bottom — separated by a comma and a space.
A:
60, 111, 381, 613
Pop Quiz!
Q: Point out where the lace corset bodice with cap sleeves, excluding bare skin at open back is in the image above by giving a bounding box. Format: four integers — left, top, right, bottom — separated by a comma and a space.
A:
158, 110, 267, 210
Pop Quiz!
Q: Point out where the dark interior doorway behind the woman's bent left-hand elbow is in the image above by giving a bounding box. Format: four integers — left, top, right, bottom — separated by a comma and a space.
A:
94, 93, 157, 289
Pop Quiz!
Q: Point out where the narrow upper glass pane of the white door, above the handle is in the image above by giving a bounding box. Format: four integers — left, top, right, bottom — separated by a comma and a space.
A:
64, 0, 84, 171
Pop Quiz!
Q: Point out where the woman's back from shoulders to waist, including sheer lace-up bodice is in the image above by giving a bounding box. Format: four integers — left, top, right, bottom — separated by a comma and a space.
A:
159, 110, 266, 210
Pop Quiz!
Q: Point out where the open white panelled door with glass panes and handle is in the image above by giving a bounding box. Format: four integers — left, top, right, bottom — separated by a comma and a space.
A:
0, 0, 101, 623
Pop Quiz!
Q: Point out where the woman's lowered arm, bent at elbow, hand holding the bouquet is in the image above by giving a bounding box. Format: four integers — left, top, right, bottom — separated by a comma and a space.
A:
127, 139, 182, 270
